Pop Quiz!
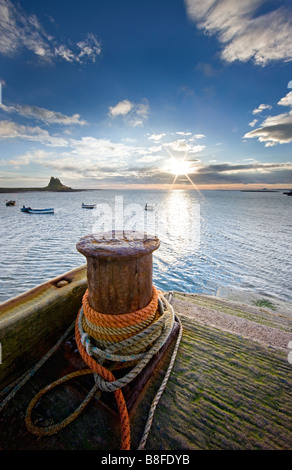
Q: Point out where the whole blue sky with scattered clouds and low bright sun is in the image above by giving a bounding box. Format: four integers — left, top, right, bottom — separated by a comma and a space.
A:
0, 0, 292, 189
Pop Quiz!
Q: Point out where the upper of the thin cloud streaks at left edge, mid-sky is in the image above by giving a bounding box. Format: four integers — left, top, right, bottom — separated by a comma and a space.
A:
0, 104, 86, 126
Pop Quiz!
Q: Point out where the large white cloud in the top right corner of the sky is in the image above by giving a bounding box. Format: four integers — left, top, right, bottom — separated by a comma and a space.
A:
185, 0, 292, 66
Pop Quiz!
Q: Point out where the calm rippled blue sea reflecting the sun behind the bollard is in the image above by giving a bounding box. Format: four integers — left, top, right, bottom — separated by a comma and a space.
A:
0, 190, 292, 302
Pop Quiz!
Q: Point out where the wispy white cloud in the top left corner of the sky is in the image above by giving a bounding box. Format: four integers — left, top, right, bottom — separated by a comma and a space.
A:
0, 0, 101, 63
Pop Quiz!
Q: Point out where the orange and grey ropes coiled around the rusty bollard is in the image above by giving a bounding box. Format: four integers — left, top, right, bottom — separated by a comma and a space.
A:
25, 286, 181, 450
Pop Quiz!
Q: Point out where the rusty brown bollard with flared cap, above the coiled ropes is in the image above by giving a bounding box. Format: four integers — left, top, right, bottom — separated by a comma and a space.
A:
76, 231, 160, 315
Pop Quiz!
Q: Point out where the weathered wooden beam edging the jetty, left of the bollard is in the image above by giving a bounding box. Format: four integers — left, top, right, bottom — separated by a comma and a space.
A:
0, 265, 87, 390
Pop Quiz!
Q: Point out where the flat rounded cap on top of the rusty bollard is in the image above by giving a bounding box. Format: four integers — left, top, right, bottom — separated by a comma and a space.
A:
76, 230, 160, 259
